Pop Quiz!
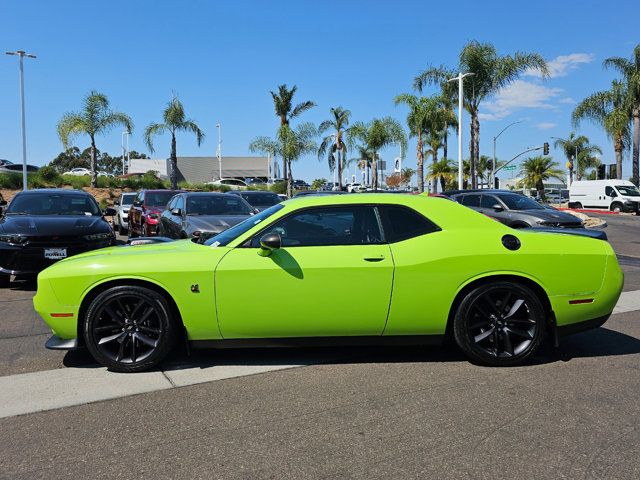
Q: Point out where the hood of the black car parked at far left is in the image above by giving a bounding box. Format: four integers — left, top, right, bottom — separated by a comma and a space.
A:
0, 215, 111, 236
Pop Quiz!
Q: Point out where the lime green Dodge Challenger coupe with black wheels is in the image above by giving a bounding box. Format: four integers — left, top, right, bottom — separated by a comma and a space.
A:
34, 193, 623, 372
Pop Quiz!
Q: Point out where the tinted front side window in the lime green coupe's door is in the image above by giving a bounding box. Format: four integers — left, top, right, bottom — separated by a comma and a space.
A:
250, 205, 384, 248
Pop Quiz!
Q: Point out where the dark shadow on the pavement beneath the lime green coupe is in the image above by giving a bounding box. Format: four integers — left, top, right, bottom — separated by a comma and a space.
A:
63, 327, 640, 370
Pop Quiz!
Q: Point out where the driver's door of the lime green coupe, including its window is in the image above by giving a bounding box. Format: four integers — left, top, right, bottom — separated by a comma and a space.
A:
215, 205, 393, 338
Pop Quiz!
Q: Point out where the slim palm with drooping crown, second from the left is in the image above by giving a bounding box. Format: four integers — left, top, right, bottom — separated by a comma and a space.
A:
144, 97, 204, 190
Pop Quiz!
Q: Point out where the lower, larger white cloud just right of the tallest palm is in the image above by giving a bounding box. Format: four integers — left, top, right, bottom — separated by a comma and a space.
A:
479, 80, 562, 120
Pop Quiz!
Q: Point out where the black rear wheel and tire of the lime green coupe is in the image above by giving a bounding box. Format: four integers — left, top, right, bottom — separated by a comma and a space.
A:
453, 282, 546, 367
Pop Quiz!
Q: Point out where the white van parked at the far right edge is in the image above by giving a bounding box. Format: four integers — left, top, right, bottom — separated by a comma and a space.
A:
569, 180, 640, 214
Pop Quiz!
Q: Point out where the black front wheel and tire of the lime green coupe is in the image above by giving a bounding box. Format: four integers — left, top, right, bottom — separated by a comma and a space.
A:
84, 285, 179, 373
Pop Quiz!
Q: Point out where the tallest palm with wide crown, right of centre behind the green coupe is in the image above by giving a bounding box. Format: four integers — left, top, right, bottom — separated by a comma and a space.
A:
414, 40, 549, 188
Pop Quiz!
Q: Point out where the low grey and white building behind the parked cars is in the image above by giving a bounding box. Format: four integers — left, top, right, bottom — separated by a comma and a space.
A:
128, 157, 272, 183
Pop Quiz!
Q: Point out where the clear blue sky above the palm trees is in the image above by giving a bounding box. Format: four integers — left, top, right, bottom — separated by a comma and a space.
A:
0, 0, 640, 180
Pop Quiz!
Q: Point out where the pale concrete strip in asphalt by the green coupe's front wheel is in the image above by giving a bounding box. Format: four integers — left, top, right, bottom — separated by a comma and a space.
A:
0, 365, 304, 418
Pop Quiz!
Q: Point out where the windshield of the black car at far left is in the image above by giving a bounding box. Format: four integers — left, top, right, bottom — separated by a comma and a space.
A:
6, 193, 102, 215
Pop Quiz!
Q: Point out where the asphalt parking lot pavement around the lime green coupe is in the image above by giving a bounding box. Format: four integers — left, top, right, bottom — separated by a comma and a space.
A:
0, 215, 640, 479
